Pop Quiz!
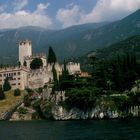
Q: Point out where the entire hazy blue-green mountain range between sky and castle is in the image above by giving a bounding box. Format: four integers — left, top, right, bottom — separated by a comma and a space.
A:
0, 10, 140, 62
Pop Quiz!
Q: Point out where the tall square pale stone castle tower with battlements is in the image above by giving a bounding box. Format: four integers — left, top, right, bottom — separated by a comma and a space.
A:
19, 40, 32, 65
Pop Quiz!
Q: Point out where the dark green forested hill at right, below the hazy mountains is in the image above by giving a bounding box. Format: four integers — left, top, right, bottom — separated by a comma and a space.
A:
77, 35, 140, 70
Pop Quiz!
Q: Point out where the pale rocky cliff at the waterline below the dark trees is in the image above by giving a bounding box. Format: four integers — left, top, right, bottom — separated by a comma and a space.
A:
49, 106, 140, 120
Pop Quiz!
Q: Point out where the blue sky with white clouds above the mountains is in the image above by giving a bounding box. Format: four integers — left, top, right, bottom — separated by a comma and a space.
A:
0, 0, 140, 29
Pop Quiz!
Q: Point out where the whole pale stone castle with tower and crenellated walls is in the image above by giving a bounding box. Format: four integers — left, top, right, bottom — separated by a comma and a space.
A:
0, 40, 81, 90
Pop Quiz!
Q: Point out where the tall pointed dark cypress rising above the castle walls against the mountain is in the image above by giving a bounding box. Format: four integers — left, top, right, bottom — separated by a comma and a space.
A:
48, 46, 57, 64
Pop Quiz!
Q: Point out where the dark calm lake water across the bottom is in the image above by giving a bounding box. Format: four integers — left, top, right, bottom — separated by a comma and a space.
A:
0, 119, 140, 140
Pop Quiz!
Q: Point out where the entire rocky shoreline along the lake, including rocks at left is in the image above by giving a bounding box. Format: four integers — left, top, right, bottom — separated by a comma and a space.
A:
10, 105, 140, 121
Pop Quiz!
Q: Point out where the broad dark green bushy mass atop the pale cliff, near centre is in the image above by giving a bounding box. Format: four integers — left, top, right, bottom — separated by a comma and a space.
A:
65, 88, 101, 110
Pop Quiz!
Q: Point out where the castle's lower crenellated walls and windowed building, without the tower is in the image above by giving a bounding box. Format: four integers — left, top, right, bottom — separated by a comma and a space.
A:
0, 59, 81, 90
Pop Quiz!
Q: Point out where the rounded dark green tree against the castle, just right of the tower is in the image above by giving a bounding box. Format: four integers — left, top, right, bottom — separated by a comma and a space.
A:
30, 58, 43, 69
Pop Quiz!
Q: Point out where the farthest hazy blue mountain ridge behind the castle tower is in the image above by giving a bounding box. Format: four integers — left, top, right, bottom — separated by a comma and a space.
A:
0, 23, 106, 63
